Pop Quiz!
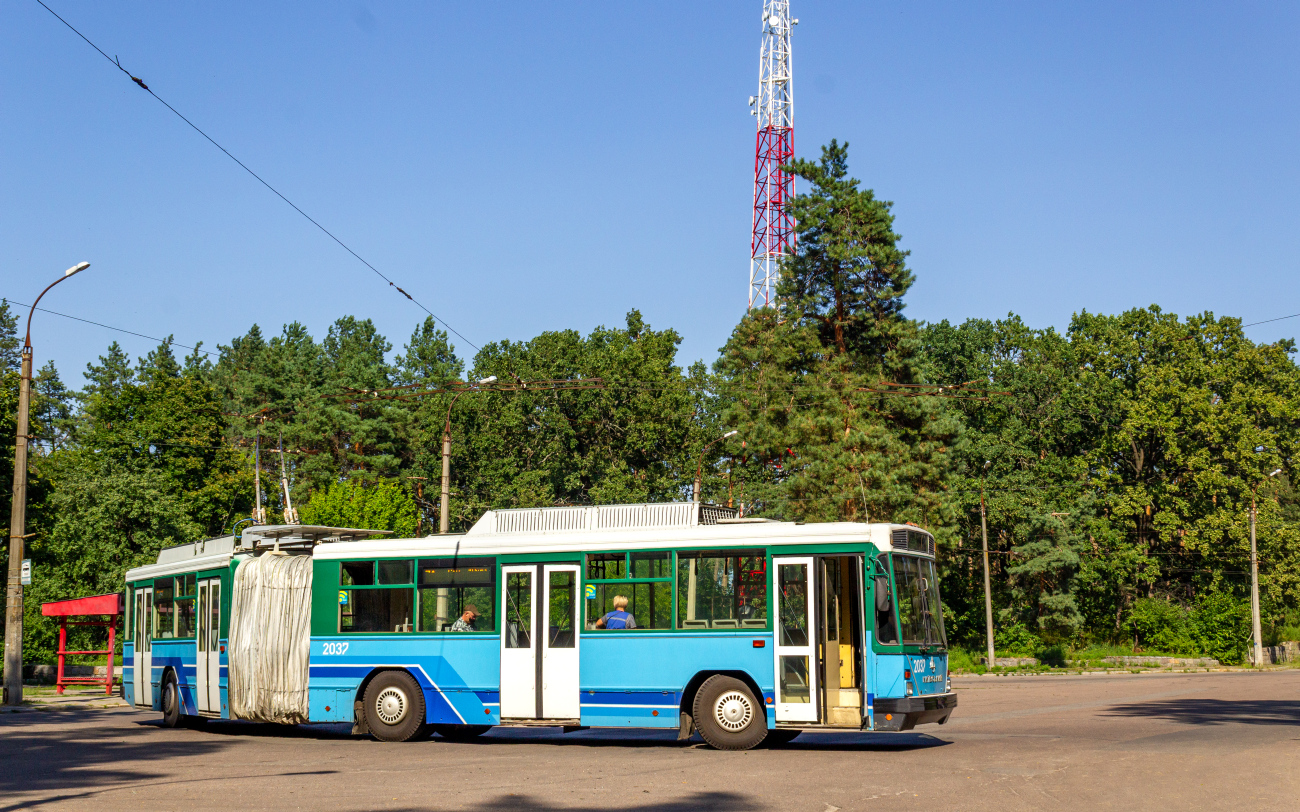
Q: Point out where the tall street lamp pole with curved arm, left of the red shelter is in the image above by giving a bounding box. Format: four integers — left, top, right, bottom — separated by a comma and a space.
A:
4, 262, 90, 705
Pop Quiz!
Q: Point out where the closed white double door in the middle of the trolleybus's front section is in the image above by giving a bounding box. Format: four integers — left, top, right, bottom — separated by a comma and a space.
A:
501, 564, 580, 720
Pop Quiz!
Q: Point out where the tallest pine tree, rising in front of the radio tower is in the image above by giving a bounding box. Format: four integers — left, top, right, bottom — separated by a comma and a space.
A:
718, 142, 961, 524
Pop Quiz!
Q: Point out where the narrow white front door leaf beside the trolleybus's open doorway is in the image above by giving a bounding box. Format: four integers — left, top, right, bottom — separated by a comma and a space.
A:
772, 556, 820, 722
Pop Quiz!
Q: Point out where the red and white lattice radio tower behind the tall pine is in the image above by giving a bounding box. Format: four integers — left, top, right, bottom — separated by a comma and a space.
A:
749, 0, 800, 309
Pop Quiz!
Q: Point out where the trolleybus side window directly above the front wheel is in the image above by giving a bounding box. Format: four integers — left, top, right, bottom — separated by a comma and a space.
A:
677, 550, 767, 629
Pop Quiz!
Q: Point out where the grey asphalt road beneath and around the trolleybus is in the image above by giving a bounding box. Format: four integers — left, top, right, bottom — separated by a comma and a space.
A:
0, 670, 1300, 812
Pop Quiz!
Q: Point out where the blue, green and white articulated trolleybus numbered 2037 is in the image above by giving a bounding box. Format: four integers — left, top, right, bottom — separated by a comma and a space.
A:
124, 503, 957, 750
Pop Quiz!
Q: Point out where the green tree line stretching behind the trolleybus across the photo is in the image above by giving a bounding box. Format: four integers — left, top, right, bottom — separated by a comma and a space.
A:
0, 142, 1300, 661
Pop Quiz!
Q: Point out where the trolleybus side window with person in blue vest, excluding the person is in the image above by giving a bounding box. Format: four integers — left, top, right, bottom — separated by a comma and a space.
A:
584, 551, 672, 631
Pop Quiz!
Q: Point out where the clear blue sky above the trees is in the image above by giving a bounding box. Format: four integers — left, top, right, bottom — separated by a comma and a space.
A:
0, 0, 1300, 386
